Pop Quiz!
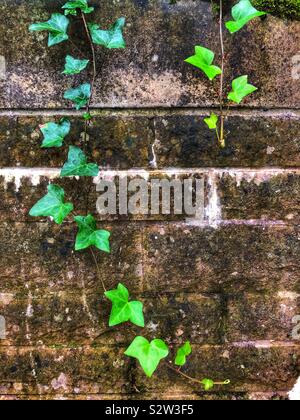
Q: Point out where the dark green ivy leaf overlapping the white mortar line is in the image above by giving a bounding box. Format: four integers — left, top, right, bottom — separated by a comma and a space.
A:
60, 146, 99, 177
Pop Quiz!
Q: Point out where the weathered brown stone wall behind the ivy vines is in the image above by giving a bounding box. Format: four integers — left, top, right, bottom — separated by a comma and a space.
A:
0, 0, 300, 399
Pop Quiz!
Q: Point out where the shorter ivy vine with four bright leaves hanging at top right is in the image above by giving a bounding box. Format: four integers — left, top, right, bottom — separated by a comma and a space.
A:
185, 0, 266, 148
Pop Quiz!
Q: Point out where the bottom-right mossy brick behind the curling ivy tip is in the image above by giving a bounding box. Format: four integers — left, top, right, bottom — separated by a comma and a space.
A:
136, 346, 300, 393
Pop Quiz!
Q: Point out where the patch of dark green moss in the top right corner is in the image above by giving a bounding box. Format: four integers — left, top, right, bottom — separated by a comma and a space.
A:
252, 0, 300, 20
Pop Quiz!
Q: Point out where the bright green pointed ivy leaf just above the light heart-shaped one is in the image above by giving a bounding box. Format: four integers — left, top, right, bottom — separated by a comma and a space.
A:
105, 283, 145, 327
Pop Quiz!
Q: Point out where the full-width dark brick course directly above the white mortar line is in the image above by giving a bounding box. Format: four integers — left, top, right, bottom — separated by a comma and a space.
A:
0, 111, 300, 170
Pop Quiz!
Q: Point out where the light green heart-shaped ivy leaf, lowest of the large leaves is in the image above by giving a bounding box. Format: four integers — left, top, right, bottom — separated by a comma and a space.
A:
125, 337, 169, 378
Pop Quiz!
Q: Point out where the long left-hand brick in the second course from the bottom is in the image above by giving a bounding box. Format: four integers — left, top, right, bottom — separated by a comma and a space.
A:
0, 290, 222, 347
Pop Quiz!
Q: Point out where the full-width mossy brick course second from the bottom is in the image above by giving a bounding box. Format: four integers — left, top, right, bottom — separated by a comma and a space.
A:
0, 290, 300, 348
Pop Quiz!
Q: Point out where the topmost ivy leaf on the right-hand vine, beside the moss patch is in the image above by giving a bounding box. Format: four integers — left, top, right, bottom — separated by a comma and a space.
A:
226, 0, 267, 34
